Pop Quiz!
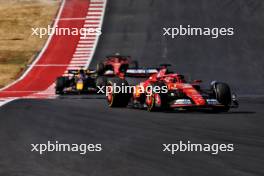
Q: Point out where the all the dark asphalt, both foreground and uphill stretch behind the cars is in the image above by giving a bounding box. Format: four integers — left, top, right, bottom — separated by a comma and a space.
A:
0, 0, 264, 176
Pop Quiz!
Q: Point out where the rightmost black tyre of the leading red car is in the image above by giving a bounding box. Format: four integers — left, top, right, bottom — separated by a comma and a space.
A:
213, 83, 232, 112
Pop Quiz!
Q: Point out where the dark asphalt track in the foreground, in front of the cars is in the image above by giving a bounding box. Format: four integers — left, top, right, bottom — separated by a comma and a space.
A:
0, 96, 264, 176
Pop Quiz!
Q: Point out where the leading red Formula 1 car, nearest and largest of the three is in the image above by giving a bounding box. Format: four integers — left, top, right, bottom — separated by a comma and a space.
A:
107, 67, 238, 112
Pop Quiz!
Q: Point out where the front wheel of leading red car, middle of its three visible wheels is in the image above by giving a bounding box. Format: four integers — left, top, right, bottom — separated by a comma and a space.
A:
146, 82, 169, 112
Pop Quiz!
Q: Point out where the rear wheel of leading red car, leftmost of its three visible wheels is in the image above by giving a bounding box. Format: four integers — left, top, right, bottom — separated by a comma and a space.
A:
107, 78, 131, 107
